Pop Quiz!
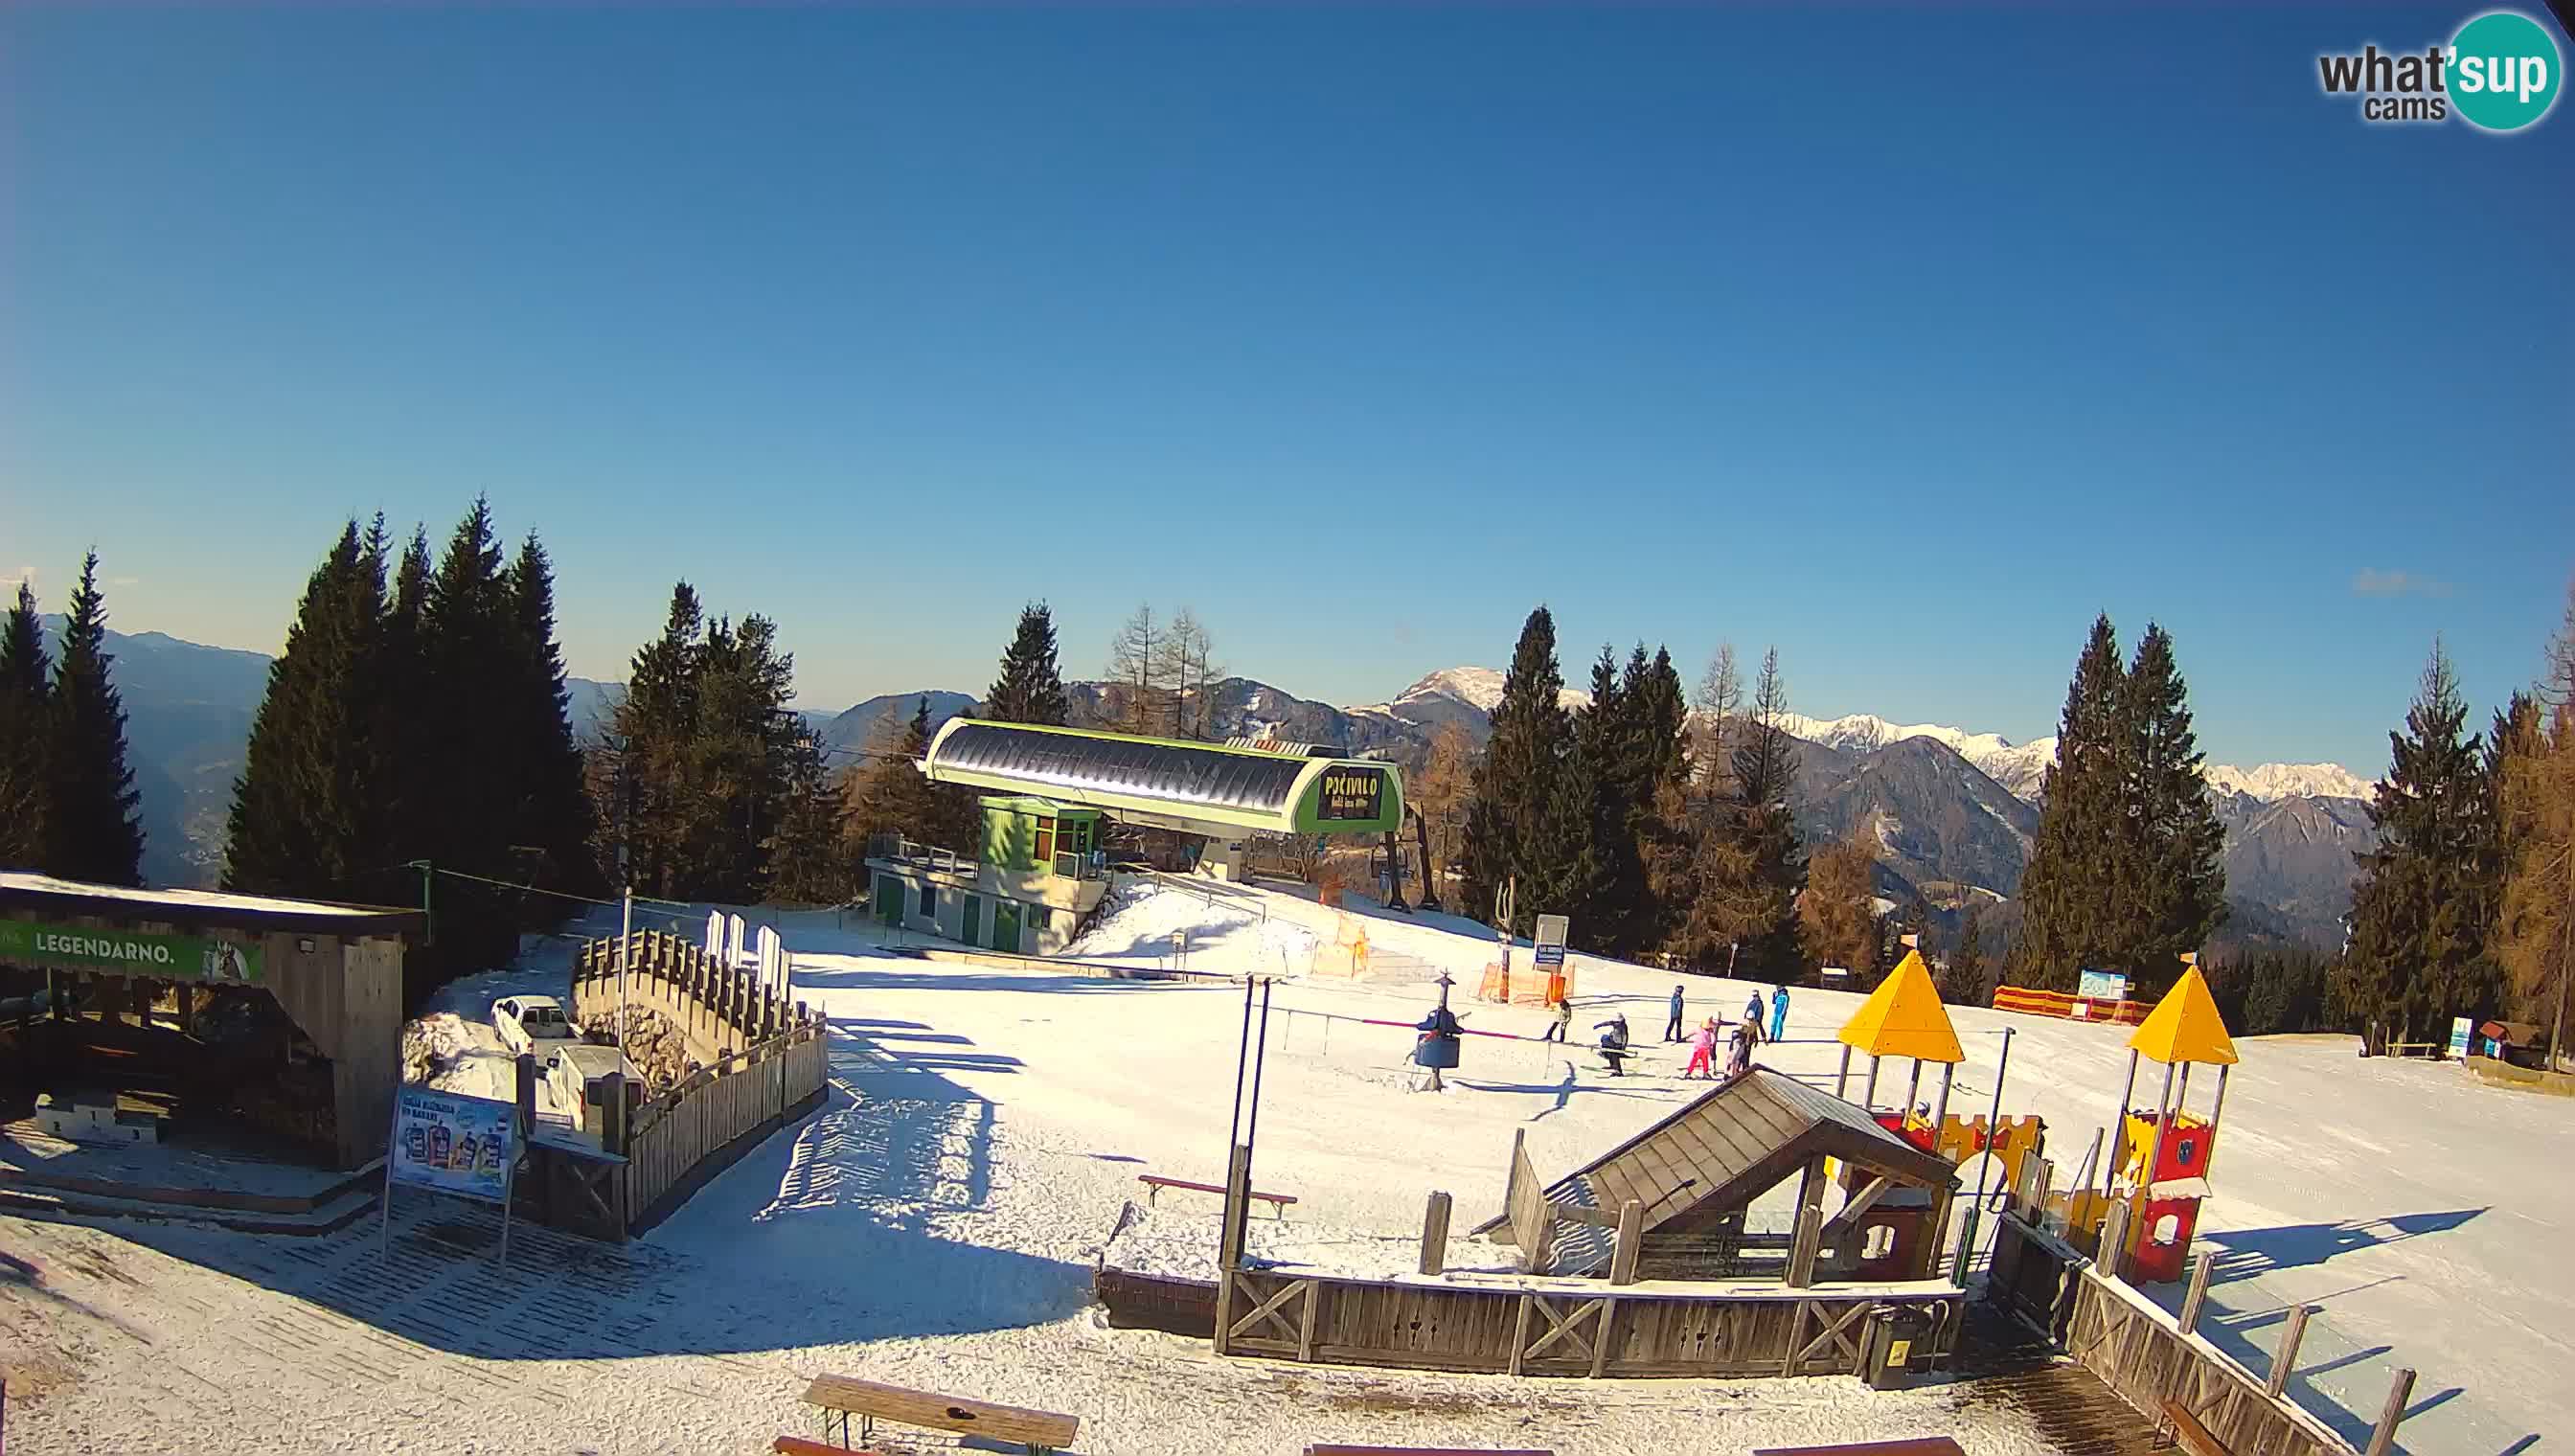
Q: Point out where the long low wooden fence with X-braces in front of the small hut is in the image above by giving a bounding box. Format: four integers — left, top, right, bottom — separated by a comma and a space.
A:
1199, 1270, 1962, 1376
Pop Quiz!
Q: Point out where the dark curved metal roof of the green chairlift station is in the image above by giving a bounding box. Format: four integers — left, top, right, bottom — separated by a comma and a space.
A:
929, 719, 1313, 814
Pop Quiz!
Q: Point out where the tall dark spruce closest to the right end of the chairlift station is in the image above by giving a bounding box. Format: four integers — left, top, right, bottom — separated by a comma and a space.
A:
1465, 605, 1591, 936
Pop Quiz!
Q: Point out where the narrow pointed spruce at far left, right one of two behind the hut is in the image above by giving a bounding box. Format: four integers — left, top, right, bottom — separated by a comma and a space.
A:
41, 552, 145, 884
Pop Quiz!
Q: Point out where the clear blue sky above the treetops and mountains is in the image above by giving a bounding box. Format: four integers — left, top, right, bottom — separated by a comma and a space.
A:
0, 5, 2575, 770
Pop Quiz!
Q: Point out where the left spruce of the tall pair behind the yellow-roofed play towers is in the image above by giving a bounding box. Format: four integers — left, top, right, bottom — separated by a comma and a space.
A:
2003, 616, 2132, 990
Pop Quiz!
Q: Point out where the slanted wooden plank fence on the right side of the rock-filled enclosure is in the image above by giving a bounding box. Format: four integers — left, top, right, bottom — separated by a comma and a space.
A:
613, 1015, 824, 1232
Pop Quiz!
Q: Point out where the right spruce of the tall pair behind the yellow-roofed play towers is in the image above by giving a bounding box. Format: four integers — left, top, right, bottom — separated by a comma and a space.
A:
2119, 624, 2227, 994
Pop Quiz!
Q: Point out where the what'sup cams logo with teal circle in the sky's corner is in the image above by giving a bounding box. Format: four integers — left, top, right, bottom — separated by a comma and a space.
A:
2315, 11, 2564, 131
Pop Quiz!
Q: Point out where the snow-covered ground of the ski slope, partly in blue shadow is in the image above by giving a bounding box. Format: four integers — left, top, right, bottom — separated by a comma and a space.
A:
0, 886, 2575, 1456
